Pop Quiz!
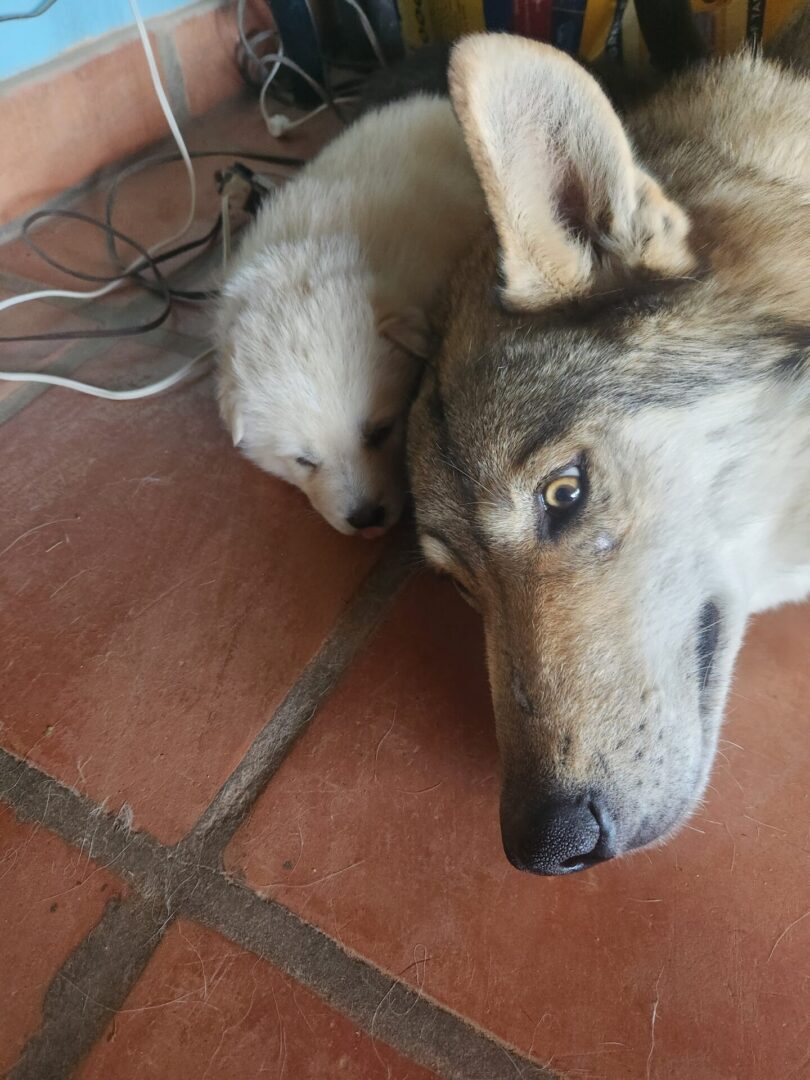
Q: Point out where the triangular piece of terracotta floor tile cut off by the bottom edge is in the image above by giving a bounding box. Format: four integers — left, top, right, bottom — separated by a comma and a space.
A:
77, 922, 433, 1080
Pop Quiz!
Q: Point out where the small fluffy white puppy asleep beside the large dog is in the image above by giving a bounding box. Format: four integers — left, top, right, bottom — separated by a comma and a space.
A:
212, 96, 485, 538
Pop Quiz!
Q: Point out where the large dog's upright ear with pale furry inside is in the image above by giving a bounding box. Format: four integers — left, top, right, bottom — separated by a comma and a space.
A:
449, 33, 694, 310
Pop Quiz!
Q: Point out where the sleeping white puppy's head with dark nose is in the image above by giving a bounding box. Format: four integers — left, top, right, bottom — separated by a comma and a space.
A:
218, 238, 428, 537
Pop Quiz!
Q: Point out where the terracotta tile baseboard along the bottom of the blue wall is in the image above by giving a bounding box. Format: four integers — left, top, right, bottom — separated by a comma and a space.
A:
0, 0, 270, 227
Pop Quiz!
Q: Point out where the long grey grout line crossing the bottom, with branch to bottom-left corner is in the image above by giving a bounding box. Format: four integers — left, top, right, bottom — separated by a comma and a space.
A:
0, 750, 555, 1080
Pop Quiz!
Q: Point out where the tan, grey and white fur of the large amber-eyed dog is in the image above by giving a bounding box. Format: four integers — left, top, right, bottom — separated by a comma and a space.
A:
409, 27, 810, 868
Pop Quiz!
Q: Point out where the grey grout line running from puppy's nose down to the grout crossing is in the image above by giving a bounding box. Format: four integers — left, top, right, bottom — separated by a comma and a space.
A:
180, 532, 416, 860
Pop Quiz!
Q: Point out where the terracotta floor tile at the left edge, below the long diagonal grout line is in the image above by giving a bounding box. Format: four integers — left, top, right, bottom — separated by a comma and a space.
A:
0, 804, 125, 1076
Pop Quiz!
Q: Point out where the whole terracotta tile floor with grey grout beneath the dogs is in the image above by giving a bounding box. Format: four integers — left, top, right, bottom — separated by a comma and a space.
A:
0, 90, 810, 1080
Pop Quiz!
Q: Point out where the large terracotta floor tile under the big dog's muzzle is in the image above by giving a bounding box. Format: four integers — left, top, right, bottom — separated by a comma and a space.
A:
227, 578, 810, 1080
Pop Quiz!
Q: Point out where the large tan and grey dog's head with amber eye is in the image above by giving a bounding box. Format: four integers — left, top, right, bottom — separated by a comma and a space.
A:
408, 36, 803, 874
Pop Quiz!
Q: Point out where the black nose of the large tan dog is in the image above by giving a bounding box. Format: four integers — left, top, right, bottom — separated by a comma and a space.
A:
501, 796, 616, 875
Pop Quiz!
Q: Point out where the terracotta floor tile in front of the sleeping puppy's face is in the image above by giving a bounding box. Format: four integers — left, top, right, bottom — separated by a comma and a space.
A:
0, 354, 381, 842
